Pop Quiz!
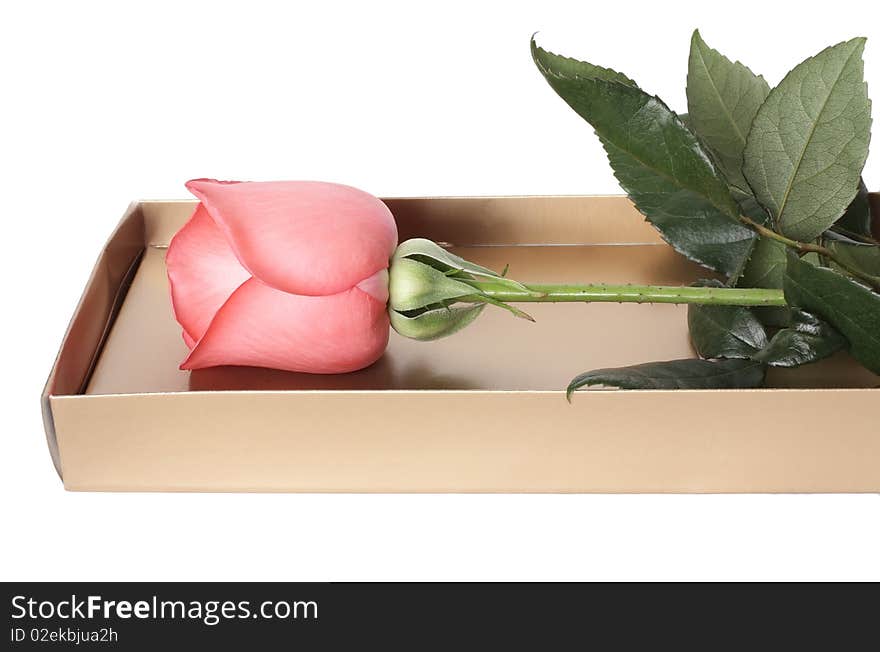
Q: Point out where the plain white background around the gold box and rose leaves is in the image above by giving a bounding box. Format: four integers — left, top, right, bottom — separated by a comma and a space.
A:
0, 0, 880, 580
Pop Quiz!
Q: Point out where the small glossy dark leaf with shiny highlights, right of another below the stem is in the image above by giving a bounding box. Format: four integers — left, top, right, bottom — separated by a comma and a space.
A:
754, 309, 846, 367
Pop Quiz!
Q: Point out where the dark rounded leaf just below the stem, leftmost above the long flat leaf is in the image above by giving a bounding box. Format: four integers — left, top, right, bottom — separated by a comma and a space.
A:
688, 281, 767, 358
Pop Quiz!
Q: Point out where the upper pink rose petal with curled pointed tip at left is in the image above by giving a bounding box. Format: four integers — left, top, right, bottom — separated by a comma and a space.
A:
186, 179, 397, 296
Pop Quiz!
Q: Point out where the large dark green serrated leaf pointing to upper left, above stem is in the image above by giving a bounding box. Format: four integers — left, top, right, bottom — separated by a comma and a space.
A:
532, 41, 754, 275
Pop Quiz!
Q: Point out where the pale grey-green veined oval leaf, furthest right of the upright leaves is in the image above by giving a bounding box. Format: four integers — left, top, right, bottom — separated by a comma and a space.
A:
743, 38, 871, 242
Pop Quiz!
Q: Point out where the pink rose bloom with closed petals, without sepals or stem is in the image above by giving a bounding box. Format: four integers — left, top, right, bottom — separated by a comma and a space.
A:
166, 179, 397, 373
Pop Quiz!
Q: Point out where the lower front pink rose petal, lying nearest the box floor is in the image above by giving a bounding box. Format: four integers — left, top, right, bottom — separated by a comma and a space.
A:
180, 278, 389, 374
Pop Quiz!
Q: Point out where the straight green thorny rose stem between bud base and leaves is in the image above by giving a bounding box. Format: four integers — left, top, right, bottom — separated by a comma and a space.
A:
462, 280, 786, 306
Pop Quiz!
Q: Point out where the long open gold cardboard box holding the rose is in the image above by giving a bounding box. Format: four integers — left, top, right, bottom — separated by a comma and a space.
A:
43, 196, 880, 492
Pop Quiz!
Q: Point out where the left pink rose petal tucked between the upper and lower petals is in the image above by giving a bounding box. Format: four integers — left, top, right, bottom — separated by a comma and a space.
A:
165, 204, 251, 348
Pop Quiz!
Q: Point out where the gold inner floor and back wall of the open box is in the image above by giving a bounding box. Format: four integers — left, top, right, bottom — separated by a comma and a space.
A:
86, 197, 880, 394
